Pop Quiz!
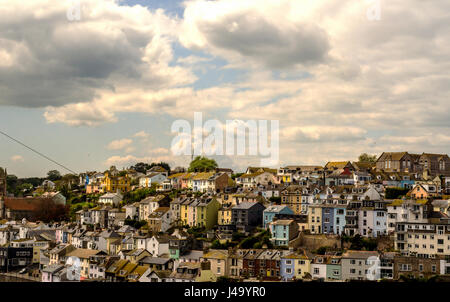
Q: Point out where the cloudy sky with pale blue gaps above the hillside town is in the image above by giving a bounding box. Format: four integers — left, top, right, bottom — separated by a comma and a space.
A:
0, 0, 450, 177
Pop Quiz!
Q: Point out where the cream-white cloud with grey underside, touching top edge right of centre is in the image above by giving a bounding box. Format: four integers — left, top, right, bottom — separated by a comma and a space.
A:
180, 0, 329, 68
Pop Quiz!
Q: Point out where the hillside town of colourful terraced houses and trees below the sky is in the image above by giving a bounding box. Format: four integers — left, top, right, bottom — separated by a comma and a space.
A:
0, 152, 450, 282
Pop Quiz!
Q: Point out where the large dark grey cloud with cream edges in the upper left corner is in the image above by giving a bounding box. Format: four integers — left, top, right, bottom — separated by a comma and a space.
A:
0, 1, 192, 107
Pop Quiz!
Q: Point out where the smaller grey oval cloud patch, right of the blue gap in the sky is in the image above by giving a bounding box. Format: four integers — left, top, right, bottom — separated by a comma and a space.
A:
198, 12, 330, 69
